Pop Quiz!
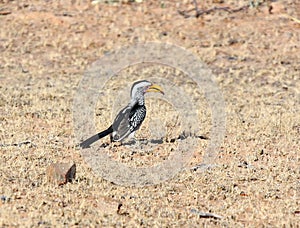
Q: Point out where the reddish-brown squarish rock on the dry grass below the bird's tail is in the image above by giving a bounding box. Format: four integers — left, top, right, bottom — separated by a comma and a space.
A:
46, 162, 76, 185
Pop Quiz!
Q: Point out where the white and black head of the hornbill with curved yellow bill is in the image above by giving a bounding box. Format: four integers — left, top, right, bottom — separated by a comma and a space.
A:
131, 80, 164, 98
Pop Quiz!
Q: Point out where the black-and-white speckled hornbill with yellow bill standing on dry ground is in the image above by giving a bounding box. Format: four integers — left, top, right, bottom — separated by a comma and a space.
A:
79, 80, 164, 148
